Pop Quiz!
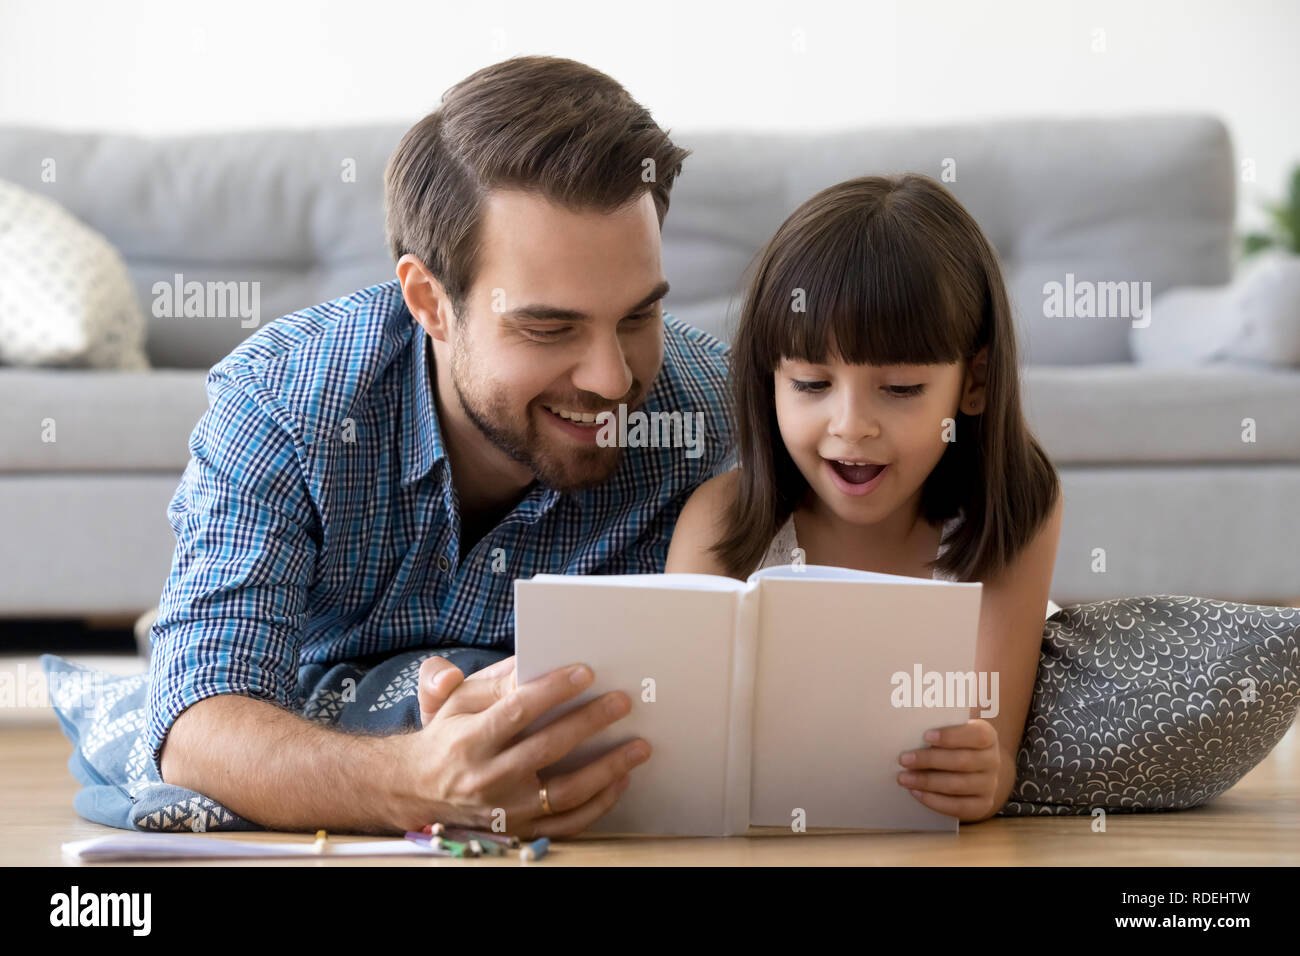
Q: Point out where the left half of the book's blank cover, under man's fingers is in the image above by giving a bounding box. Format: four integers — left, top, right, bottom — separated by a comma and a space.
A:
515, 575, 751, 836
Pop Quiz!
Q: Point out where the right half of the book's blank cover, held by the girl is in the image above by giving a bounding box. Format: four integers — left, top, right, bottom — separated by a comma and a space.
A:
750, 566, 982, 831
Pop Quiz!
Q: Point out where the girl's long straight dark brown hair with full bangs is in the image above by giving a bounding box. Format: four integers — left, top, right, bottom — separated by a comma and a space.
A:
711, 174, 1060, 580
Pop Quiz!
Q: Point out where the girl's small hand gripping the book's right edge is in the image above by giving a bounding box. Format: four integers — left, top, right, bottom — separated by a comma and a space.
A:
898, 718, 1002, 821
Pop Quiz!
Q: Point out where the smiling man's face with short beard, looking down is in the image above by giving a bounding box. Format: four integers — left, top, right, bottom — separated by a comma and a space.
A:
447, 190, 668, 490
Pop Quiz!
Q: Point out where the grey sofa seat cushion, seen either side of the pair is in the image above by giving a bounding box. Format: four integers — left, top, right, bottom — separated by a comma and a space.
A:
0, 361, 1300, 473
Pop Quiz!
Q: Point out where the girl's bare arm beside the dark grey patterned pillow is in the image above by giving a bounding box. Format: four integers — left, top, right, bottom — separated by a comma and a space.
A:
971, 494, 1065, 819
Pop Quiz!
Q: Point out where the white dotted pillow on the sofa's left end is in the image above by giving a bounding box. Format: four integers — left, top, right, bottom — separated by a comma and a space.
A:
0, 179, 148, 371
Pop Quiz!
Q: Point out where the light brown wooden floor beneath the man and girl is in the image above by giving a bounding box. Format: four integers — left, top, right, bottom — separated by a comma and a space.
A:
0, 719, 1300, 866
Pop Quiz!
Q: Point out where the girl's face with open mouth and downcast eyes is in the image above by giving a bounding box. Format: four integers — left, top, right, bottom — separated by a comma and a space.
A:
775, 359, 983, 524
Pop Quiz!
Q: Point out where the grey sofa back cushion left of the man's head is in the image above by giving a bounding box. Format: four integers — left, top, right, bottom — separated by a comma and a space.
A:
0, 124, 406, 368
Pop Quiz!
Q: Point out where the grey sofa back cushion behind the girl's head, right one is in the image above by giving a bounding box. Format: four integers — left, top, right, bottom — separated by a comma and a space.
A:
663, 116, 1235, 365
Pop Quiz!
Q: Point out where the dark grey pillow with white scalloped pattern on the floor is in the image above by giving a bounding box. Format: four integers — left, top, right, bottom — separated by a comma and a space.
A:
998, 594, 1300, 817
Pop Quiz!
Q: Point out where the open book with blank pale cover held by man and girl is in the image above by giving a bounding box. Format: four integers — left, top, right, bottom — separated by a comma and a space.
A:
515, 564, 977, 836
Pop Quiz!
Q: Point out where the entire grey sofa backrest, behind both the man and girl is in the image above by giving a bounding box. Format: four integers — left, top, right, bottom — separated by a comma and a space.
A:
0, 116, 1235, 368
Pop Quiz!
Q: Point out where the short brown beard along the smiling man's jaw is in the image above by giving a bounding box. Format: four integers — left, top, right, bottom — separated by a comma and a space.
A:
451, 329, 641, 492
